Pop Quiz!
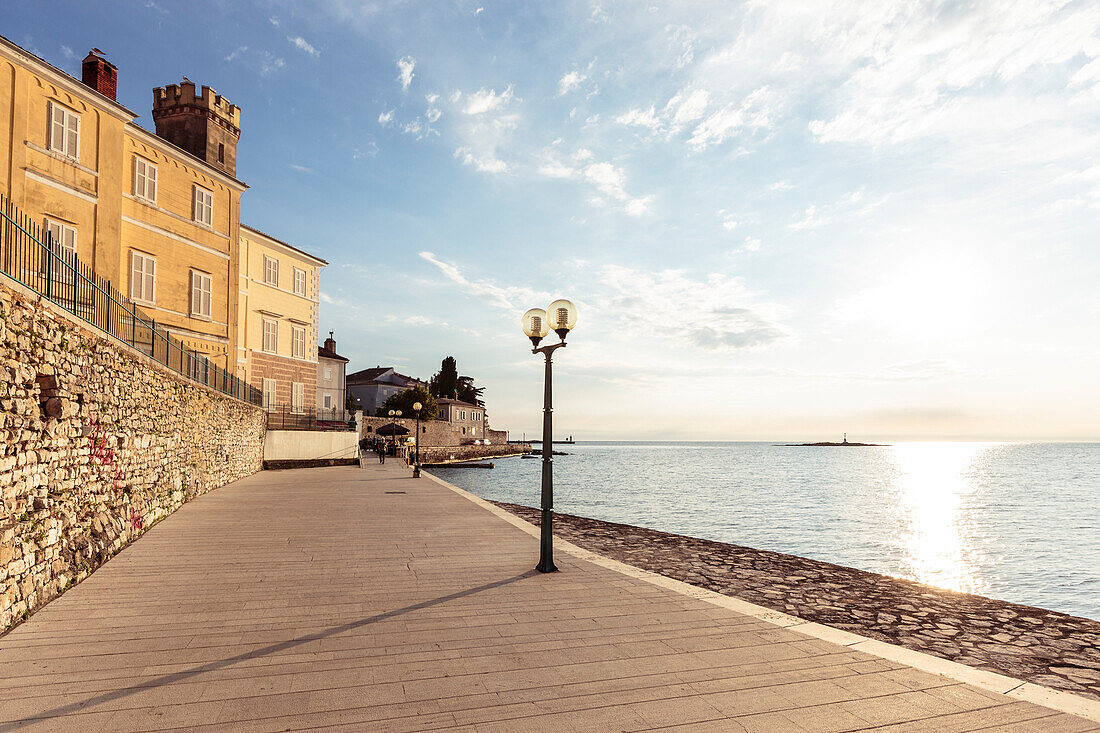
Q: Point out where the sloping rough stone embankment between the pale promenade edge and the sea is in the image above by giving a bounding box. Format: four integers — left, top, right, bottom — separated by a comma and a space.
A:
494, 502, 1100, 699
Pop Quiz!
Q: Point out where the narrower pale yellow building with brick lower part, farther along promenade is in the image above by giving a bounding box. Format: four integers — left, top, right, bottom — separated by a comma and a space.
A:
238, 226, 328, 413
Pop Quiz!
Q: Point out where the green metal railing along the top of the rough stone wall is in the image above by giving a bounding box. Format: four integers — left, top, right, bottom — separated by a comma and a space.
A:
0, 196, 263, 405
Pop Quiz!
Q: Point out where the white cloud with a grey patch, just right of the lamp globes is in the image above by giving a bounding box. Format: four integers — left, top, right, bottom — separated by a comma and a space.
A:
600, 265, 790, 351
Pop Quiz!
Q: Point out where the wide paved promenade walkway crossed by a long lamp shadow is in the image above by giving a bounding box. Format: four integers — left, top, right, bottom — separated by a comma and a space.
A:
0, 464, 1100, 733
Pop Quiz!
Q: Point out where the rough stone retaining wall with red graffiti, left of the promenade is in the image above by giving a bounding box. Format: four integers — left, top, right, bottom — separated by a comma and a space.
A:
0, 282, 265, 633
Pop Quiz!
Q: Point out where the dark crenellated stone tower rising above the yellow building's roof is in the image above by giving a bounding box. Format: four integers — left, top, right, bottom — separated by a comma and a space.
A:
153, 77, 241, 178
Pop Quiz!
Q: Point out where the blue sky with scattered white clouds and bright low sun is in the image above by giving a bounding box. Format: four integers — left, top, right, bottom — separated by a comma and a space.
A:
0, 0, 1100, 440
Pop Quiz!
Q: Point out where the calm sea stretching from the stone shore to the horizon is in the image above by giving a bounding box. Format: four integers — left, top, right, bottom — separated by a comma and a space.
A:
432, 442, 1100, 619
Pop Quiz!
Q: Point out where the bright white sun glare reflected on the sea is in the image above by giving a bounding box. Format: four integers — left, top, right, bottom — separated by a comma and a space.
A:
893, 442, 986, 593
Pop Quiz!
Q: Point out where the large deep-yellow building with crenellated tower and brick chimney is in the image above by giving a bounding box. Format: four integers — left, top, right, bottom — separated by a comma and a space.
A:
0, 37, 247, 363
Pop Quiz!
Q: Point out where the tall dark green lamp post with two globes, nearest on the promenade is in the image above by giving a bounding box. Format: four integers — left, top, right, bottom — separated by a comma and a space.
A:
521, 300, 576, 572
